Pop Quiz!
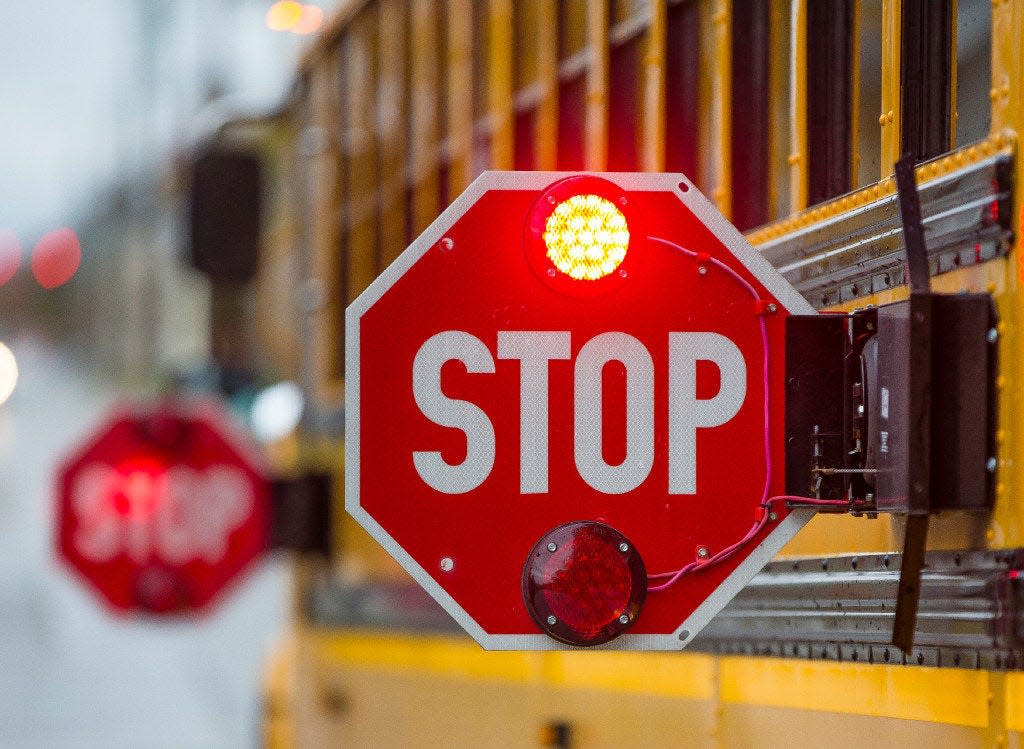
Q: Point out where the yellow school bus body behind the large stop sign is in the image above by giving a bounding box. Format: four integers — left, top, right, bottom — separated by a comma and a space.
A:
237, 0, 1024, 747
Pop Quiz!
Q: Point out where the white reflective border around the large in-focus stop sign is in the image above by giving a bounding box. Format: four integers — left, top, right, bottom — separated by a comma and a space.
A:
344, 171, 815, 651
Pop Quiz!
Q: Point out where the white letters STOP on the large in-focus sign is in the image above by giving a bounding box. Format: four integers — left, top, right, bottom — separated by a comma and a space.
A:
413, 330, 746, 494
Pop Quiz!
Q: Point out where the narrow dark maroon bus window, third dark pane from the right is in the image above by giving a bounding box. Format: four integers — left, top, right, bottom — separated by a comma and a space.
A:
730, 0, 770, 232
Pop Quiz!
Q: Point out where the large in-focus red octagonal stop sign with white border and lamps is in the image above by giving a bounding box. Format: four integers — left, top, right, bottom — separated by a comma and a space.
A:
346, 172, 812, 649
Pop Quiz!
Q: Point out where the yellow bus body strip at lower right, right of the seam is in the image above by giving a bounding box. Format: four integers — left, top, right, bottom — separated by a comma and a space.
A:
721, 658, 989, 727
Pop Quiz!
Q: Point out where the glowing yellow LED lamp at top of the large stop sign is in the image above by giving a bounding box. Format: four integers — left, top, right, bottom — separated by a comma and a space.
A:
544, 195, 630, 281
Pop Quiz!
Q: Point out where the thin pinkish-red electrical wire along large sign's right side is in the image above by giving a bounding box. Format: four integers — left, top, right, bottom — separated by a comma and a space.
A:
647, 237, 853, 593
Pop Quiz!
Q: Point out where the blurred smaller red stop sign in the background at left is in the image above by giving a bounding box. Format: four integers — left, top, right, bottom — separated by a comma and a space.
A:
56, 408, 269, 614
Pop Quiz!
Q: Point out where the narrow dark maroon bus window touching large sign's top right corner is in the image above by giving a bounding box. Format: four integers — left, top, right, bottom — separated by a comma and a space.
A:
665, 0, 700, 186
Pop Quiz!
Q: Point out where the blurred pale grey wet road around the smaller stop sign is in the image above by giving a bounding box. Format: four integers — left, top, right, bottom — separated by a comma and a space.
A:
0, 338, 287, 749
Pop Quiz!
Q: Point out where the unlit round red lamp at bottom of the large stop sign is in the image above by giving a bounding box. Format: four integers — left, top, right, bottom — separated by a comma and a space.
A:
522, 521, 647, 646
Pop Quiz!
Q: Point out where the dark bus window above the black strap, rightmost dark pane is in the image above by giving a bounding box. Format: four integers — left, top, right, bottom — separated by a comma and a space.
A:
900, 0, 952, 161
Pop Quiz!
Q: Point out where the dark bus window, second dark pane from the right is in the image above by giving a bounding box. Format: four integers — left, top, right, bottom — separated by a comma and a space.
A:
806, 0, 854, 205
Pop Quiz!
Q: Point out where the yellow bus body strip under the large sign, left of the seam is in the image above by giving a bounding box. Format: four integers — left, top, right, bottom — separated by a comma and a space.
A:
314, 630, 715, 700
